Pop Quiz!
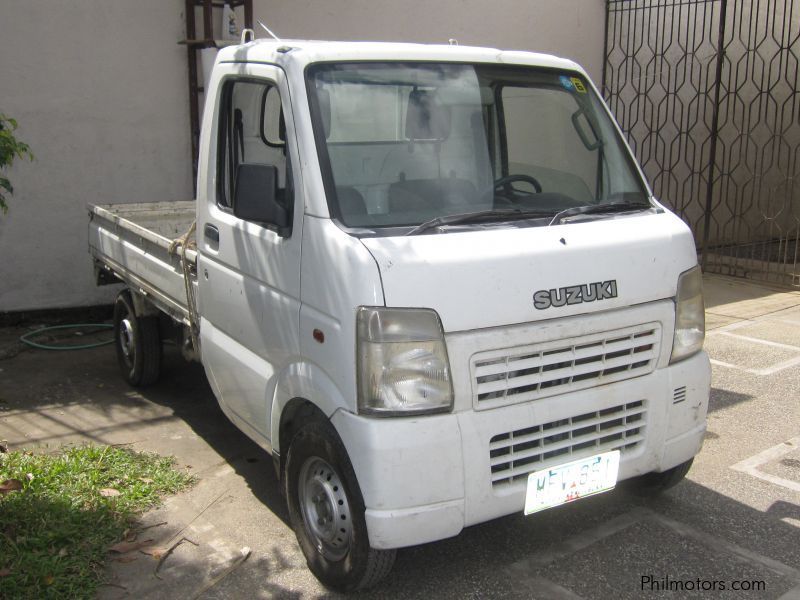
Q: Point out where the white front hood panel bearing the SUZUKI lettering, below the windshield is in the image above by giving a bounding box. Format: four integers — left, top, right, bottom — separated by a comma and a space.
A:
362, 212, 697, 332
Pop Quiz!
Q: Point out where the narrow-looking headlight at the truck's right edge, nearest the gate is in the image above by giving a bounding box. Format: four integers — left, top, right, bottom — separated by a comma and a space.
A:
669, 267, 706, 363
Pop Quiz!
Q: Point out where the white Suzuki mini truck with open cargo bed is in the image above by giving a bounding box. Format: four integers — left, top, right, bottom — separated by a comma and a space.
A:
89, 41, 710, 591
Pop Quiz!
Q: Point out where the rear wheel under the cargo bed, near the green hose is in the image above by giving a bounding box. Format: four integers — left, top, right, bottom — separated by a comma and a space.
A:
114, 290, 161, 387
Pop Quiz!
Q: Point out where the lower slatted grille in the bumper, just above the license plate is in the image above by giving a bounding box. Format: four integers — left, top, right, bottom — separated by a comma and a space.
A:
489, 400, 646, 487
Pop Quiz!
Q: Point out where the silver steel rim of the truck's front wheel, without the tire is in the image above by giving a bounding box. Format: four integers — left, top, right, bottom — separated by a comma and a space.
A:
297, 456, 353, 560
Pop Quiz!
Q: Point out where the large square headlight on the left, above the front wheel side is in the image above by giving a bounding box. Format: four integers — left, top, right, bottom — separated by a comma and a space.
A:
356, 307, 453, 416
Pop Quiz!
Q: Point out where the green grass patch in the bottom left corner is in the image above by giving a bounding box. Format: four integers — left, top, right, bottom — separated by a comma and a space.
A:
0, 446, 193, 598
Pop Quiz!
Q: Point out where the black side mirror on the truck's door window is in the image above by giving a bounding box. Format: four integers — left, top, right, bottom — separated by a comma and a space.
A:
233, 163, 292, 237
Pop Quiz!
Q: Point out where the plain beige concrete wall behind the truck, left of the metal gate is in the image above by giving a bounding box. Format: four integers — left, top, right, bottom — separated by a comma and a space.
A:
0, 0, 605, 312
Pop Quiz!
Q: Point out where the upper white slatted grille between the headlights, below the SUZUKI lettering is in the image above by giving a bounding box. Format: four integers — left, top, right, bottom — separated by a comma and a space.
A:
472, 323, 661, 409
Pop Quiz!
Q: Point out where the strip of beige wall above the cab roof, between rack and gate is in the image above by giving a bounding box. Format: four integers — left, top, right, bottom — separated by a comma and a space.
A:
254, 0, 605, 85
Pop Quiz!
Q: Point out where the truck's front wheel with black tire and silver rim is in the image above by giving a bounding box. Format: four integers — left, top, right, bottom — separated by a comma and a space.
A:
284, 421, 396, 592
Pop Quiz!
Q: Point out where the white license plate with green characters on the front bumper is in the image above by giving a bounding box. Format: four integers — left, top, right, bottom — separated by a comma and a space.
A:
525, 450, 619, 515
